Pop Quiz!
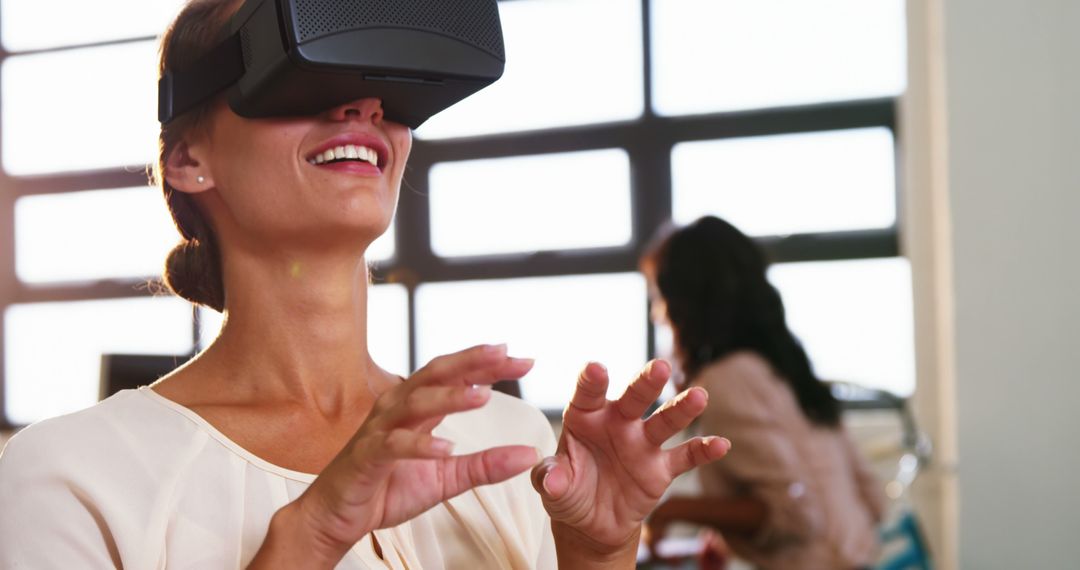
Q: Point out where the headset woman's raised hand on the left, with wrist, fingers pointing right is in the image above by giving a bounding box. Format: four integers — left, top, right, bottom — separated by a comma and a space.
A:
252, 345, 538, 568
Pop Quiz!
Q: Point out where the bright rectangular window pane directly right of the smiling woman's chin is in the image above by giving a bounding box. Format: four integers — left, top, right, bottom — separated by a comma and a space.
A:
430, 150, 631, 256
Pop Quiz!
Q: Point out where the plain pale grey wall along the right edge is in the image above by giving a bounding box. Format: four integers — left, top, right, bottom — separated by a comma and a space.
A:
942, 0, 1080, 570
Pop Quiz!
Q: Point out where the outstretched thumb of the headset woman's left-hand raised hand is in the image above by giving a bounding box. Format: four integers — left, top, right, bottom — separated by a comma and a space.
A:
443, 446, 539, 499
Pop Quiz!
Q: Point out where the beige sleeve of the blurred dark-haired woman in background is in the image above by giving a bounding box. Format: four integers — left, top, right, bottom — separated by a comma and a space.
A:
700, 358, 823, 549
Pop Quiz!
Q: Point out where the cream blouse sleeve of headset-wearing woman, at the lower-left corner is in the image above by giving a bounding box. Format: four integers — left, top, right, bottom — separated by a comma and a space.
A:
0, 428, 121, 570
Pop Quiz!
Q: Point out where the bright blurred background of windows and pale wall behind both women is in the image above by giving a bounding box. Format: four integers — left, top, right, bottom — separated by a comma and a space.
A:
0, 0, 1080, 569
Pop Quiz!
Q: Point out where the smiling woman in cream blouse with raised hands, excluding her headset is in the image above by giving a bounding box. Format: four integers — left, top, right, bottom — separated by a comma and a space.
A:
0, 0, 729, 569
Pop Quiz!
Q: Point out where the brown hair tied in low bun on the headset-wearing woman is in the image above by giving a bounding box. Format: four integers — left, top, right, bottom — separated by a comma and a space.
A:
153, 0, 238, 311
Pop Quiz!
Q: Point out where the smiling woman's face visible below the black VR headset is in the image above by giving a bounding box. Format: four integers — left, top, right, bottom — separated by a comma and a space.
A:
191, 98, 413, 253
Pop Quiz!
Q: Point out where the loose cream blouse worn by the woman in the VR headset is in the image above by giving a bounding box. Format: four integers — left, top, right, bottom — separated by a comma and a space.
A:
0, 388, 556, 570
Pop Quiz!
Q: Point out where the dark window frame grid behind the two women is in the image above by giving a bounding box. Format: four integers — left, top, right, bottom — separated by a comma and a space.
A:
0, 0, 902, 429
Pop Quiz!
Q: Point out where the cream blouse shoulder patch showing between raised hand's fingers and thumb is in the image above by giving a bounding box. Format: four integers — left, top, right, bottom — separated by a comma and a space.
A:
436, 392, 555, 454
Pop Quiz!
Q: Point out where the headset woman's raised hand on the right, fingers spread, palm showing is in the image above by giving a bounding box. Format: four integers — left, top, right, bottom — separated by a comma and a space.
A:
532, 361, 731, 566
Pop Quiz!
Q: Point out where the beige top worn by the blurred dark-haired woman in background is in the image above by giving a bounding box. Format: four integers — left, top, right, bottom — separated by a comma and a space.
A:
694, 352, 885, 570
